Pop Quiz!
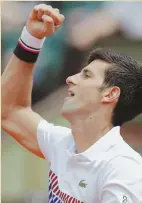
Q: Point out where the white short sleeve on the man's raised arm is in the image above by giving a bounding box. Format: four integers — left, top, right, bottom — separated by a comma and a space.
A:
37, 120, 72, 162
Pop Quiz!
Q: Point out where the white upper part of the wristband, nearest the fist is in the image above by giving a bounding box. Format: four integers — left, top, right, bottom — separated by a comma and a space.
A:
20, 26, 45, 49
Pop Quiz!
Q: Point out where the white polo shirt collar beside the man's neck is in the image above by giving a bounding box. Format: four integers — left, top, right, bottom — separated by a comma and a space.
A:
69, 126, 123, 160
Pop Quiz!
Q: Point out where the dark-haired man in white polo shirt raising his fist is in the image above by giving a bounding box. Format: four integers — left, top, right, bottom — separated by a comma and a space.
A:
2, 4, 142, 203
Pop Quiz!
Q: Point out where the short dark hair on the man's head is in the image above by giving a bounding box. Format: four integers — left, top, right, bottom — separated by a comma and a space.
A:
87, 48, 142, 126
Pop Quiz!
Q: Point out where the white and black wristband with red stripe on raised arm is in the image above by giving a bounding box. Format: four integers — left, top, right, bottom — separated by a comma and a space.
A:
14, 27, 45, 63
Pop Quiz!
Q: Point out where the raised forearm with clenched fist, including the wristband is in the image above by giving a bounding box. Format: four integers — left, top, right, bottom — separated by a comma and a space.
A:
2, 4, 64, 118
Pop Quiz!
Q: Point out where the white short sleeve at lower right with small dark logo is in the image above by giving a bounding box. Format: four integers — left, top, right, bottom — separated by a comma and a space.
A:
100, 157, 142, 203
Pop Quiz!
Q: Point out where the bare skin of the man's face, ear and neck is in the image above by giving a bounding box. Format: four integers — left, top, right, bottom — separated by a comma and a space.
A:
61, 60, 120, 153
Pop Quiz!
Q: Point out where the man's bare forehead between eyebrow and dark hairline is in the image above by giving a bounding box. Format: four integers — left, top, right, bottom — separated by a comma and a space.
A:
85, 60, 110, 75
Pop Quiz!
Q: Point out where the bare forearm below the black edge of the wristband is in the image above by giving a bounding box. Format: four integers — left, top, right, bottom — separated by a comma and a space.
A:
2, 54, 34, 116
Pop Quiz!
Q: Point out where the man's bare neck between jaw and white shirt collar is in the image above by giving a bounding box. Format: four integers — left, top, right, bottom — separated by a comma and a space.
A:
70, 114, 113, 153
